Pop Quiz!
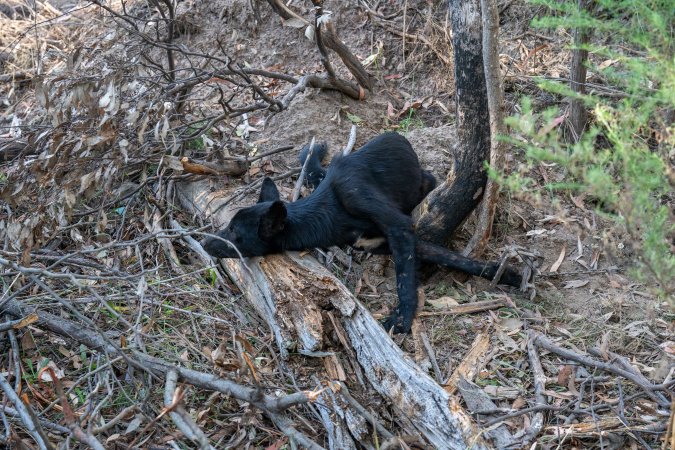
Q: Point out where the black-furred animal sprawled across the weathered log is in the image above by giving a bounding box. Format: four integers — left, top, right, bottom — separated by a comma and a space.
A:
204, 133, 521, 333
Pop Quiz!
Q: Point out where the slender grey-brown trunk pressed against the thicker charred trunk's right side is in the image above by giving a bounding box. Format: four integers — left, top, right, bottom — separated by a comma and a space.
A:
463, 0, 506, 256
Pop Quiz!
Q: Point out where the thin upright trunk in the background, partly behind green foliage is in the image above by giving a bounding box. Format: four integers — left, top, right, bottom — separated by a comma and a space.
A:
570, 0, 591, 141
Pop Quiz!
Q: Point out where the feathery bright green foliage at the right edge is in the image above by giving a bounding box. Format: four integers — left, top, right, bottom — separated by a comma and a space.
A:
503, 0, 675, 298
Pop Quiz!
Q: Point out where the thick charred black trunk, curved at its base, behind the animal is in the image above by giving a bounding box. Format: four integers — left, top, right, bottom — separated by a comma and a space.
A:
416, 0, 490, 245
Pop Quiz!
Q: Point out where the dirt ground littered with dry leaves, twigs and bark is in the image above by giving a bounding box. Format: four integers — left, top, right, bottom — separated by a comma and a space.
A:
0, 0, 675, 448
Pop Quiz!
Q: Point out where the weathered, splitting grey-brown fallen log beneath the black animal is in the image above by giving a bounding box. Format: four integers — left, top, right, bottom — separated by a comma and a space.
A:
177, 181, 486, 449
